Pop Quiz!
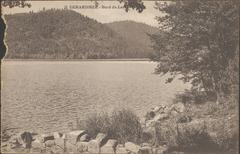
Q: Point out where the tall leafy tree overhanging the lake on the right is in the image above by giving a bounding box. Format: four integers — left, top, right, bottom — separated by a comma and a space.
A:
151, 0, 239, 102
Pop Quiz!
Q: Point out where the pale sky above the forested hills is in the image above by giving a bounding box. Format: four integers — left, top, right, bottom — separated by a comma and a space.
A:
3, 1, 163, 26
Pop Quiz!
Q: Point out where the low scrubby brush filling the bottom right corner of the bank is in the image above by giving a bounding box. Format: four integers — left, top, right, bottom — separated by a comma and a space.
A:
156, 115, 239, 154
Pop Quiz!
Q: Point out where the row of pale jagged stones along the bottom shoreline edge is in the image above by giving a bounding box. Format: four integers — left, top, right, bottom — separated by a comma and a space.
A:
2, 130, 171, 154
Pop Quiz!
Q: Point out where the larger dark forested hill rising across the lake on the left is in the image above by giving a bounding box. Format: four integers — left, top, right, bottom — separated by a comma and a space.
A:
6, 9, 133, 59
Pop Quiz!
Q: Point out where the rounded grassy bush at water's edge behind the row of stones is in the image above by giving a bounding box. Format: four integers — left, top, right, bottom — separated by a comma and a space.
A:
78, 109, 142, 143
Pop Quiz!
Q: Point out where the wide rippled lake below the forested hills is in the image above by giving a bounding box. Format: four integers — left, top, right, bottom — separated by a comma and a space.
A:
1, 60, 188, 133
